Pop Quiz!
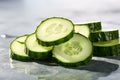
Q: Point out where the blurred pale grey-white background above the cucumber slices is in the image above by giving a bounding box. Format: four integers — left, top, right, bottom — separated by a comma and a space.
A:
0, 0, 120, 35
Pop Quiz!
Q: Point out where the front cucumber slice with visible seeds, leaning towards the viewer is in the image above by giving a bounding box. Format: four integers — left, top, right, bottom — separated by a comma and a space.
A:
53, 34, 92, 67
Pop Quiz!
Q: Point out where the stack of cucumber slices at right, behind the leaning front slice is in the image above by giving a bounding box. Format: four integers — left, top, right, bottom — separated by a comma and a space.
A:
75, 22, 120, 57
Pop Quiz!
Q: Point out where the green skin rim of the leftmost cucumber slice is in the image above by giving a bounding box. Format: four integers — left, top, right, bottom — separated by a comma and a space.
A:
10, 34, 32, 61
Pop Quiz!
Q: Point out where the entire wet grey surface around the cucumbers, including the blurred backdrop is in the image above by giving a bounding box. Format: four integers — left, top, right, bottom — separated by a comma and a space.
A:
0, 0, 120, 80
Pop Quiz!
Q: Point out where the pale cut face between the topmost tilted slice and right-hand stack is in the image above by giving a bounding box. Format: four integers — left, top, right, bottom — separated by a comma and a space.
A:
74, 24, 90, 38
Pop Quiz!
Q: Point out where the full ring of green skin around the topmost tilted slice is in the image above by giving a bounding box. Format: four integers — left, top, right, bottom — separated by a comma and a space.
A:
35, 17, 74, 46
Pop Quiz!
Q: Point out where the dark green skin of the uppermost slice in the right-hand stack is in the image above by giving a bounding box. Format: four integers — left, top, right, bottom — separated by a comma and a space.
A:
75, 22, 102, 32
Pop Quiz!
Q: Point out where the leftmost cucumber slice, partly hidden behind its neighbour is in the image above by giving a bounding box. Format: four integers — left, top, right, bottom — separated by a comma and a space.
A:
10, 35, 31, 61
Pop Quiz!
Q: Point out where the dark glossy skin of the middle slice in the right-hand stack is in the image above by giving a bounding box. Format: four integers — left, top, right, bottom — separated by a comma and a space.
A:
90, 30, 119, 42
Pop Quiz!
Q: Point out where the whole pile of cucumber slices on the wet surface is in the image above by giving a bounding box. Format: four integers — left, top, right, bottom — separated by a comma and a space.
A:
10, 17, 119, 67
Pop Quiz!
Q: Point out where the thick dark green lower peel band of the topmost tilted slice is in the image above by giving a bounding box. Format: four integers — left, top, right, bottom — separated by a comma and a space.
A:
37, 31, 74, 46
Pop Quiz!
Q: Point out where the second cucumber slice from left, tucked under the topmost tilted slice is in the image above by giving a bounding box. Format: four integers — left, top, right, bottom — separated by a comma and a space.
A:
25, 34, 53, 59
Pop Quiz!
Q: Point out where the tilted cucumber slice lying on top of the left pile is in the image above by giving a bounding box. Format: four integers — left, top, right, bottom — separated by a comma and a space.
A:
36, 17, 74, 46
